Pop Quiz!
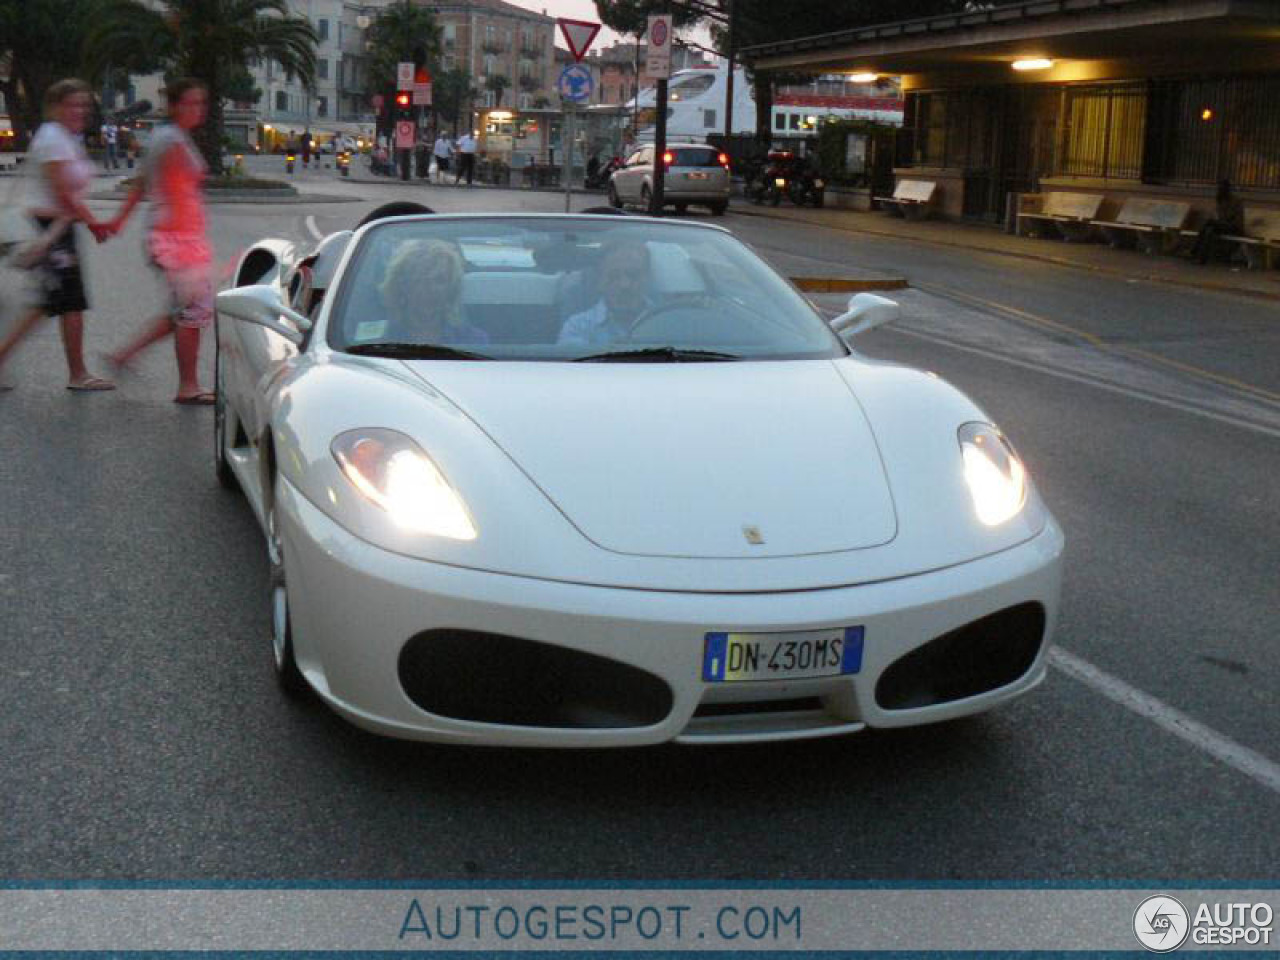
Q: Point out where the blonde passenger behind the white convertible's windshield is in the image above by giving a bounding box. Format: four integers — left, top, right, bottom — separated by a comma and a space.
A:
379, 239, 489, 346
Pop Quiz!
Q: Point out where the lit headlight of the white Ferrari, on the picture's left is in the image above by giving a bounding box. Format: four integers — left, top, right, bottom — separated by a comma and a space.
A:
329, 428, 476, 540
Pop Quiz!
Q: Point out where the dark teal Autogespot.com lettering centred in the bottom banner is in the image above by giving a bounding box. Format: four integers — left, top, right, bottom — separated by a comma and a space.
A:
399, 897, 803, 948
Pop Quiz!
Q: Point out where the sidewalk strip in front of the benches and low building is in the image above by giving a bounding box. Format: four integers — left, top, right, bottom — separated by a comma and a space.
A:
730, 198, 1280, 300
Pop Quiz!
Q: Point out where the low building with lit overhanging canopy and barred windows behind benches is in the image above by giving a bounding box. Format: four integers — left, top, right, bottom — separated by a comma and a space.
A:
744, 0, 1280, 221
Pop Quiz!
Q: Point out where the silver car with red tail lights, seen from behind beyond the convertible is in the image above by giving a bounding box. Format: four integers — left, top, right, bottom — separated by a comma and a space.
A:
609, 143, 730, 216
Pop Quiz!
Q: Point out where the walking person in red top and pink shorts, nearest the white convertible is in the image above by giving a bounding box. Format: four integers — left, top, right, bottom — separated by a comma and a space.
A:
109, 79, 215, 404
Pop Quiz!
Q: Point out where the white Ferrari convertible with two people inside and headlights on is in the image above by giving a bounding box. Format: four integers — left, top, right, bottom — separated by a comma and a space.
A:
216, 209, 1064, 746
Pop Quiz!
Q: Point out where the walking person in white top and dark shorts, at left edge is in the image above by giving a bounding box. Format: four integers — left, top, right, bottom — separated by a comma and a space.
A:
0, 79, 115, 390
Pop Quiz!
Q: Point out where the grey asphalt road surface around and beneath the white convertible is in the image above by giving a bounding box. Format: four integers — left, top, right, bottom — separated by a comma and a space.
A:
0, 161, 1280, 883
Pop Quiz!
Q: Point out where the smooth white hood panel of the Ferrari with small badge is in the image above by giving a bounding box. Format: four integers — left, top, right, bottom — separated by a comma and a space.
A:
407, 360, 897, 558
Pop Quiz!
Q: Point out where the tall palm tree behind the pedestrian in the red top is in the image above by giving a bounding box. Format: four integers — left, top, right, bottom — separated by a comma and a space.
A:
84, 0, 316, 173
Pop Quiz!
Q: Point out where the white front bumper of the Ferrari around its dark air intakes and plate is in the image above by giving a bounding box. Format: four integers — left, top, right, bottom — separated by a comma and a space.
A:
279, 483, 1064, 748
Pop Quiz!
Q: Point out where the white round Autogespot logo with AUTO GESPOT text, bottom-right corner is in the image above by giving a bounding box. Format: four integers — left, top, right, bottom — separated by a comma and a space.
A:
1133, 893, 1275, 954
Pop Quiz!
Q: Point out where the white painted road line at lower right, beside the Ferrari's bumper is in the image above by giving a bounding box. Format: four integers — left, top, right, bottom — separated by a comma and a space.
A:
1048, 646, 1280, 794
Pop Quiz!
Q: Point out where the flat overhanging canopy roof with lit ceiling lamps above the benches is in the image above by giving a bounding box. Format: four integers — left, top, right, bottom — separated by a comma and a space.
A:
741, 0, 1280, 79
